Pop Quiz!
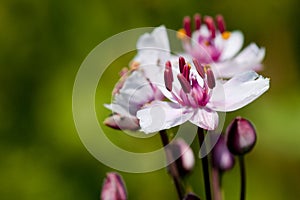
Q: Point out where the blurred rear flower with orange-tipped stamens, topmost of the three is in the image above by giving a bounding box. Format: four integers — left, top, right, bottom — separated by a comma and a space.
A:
178, 14, 265, 78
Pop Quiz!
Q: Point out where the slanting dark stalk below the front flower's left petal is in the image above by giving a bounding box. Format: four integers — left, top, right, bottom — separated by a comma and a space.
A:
159, 130, 183, 200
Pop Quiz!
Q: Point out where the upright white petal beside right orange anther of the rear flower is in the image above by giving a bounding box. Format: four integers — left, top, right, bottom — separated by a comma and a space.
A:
216, 31, 244, 60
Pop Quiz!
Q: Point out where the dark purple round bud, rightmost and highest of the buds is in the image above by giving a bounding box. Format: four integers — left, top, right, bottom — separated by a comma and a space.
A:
226, 117, 256, 155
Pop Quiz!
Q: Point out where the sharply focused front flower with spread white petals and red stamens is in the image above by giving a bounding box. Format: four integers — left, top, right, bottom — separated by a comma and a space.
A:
137, 57, 269, 133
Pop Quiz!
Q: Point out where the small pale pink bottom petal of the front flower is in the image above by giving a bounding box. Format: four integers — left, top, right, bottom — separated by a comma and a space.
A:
190, 108, 219, 130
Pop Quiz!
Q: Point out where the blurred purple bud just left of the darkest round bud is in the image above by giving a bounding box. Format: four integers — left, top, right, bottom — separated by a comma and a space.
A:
212, 135, 234, 171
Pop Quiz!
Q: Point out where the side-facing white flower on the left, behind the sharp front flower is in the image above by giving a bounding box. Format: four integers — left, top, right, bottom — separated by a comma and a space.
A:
104, 26, 170, 130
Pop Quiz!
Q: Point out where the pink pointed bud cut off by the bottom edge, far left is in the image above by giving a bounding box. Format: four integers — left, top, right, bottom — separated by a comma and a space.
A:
101, 172, 127, 200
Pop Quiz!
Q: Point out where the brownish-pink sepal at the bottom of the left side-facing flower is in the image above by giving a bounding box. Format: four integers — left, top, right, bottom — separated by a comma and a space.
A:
103, 114, 140, 131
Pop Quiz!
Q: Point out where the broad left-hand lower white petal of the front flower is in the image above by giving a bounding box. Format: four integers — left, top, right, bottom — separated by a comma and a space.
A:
137, 101, 193, 133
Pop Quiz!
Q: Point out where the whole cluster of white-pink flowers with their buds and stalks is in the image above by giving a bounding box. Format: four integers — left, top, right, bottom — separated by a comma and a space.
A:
102, 14, 269, 199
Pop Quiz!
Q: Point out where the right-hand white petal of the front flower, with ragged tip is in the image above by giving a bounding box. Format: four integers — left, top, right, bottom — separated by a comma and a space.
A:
208, 71, 270, 112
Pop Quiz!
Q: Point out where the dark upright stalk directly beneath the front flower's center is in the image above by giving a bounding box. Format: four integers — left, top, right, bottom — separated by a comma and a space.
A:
197, 127, 211, 200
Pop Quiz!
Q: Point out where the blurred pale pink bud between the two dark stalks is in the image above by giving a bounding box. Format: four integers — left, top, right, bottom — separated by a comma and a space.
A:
168, 138, 195, 177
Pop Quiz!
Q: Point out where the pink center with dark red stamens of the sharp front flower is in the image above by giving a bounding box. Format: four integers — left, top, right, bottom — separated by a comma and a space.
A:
164, 57, 215, 108
